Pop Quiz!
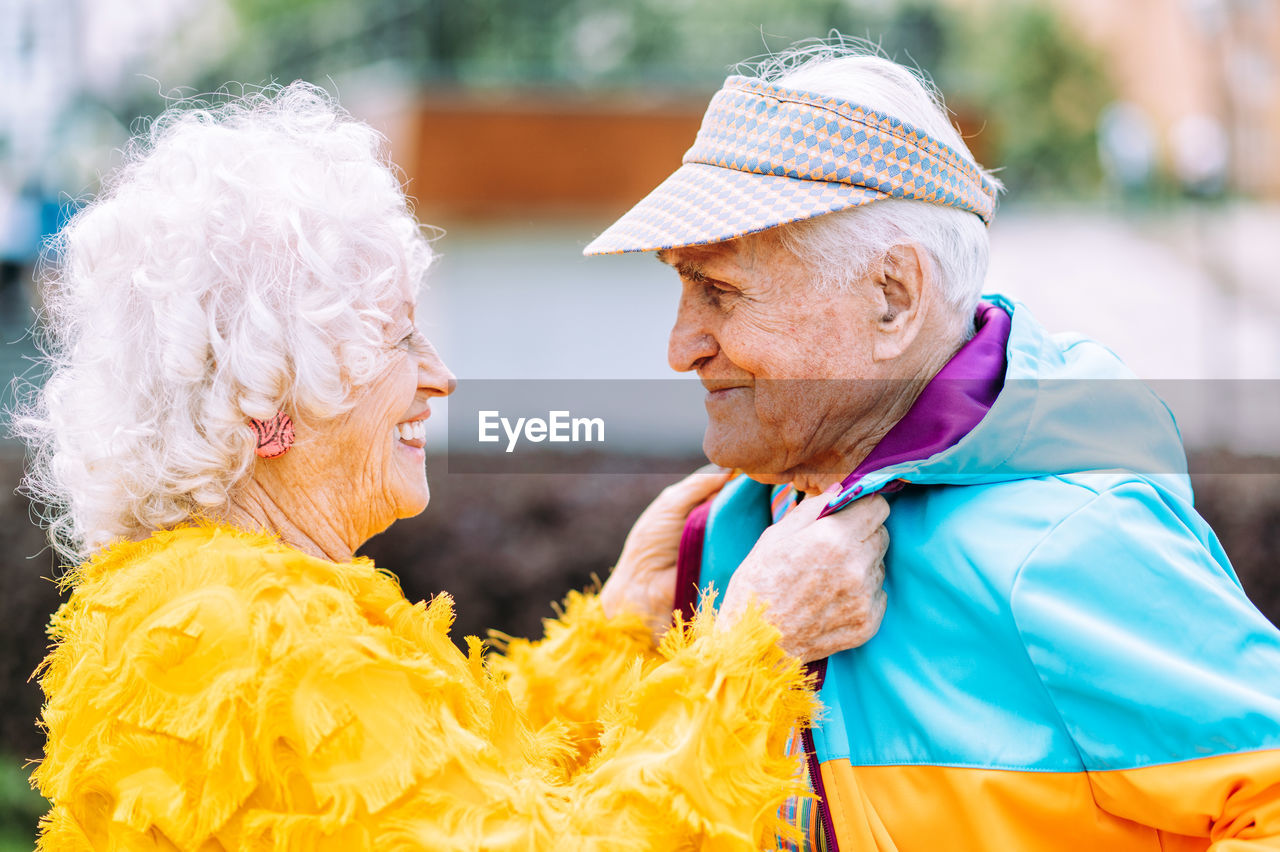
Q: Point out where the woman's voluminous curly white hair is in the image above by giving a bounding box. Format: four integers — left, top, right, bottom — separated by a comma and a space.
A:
14, 83, 431, 559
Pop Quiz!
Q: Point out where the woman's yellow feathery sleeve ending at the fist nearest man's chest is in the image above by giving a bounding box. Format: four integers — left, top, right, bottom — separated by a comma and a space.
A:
397, 596, 815, 852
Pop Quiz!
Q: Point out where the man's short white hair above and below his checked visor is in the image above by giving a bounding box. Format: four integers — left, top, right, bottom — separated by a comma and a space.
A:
754, 38, 1000, 335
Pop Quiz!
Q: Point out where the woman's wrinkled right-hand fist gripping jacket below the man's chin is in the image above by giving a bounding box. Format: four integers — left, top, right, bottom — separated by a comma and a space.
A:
719, 494, 888, 663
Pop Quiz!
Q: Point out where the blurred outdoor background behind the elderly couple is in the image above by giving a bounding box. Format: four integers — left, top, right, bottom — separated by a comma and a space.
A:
0, 0, 1280, 851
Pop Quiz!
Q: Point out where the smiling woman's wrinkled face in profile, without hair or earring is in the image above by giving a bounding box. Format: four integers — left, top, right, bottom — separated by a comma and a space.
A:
305, 299, 456, 537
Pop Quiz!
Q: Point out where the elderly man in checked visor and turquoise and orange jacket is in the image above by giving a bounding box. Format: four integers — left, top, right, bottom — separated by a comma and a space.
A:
586, 51, 1280, 852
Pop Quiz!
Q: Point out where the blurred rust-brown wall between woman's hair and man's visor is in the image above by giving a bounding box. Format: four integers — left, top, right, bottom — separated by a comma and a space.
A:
399, 91, 707, 220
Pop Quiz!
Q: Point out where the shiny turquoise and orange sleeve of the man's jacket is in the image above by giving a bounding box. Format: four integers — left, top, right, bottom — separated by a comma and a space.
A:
1011, 482, 1280, 852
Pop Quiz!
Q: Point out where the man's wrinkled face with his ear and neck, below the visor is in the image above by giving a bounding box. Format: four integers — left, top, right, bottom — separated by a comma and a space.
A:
659, 230, 963, 494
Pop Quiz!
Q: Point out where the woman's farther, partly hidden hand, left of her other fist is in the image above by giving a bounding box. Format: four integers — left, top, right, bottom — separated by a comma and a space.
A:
600, 466, 730, 635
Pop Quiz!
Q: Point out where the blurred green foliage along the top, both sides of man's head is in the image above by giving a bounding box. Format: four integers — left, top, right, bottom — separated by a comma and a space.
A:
186, 0, 1111, 194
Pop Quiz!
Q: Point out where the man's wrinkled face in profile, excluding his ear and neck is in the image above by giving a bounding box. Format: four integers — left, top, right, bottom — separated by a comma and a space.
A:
659, 232, 884, 482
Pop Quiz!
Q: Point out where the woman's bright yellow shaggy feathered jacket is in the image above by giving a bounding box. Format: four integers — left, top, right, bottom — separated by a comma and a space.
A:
33, 526, 814, 852
